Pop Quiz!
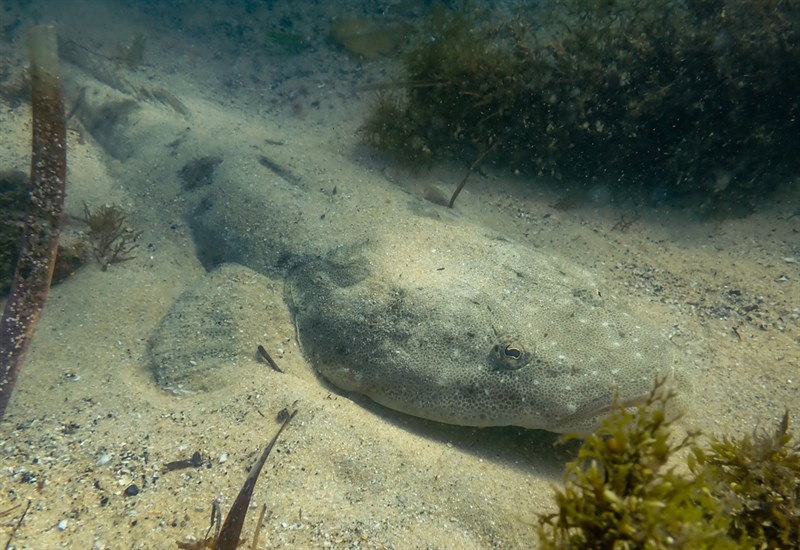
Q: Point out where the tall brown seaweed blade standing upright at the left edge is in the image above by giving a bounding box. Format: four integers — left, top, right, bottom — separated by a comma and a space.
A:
0, 26, 67, 421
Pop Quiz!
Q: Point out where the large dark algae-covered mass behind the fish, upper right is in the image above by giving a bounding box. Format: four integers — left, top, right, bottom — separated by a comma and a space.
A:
363, 0, 800, 209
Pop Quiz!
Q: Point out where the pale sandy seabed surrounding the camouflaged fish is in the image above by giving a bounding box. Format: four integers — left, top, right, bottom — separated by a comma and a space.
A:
0, 0, 800, 549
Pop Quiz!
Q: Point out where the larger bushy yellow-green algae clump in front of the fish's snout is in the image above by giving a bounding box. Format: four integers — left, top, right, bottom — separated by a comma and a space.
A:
539, 386, 736, 549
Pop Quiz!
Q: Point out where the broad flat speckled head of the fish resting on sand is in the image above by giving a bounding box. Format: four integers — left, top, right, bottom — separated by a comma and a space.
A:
287, 225, 677, 433
